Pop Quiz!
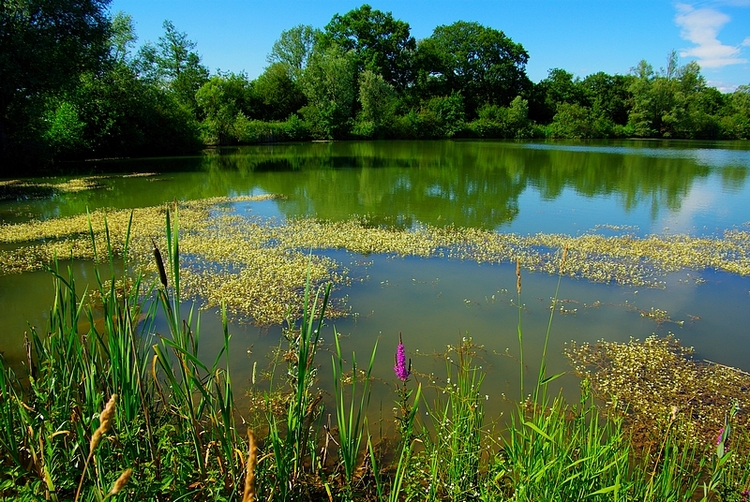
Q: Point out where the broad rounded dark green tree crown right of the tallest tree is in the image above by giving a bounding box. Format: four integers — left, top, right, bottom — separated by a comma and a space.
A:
418, 21, 531, 117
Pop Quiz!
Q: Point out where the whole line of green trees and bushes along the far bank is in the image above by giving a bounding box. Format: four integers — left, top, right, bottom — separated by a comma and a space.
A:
0, 0, 750, 175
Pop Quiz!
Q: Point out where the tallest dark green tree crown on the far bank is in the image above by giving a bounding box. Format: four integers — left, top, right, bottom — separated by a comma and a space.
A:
321, 4, 416, 90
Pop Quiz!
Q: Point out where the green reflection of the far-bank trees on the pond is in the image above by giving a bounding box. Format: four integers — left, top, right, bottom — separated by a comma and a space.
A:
204, 141, 747, 228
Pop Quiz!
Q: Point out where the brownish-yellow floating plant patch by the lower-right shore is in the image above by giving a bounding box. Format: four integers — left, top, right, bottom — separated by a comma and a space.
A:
565, 335, 750, 455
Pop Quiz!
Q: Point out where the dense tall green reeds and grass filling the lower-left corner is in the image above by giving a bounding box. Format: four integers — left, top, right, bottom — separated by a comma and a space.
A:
0, 208, 244, 500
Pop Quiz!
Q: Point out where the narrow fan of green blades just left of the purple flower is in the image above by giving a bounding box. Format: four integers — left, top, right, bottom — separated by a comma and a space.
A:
331, 329, 378, 491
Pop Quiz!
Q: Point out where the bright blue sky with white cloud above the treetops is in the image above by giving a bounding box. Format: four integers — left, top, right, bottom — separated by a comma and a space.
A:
110, 0, 750, 91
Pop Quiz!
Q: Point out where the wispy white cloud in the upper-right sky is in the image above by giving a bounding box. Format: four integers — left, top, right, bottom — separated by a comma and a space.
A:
675, 3, 750, 68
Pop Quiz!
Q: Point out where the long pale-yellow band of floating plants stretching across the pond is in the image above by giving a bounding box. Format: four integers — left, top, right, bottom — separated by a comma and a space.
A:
0, 195, 750, 324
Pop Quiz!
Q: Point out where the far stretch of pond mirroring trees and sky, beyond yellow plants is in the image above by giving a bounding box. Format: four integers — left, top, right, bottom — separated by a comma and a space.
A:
0, 141, 750, 233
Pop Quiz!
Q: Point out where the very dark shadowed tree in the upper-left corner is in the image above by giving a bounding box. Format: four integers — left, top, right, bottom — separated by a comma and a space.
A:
0, 0, 109, 174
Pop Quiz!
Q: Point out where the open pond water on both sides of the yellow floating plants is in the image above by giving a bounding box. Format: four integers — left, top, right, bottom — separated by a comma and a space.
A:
0, 141, 750, 416
